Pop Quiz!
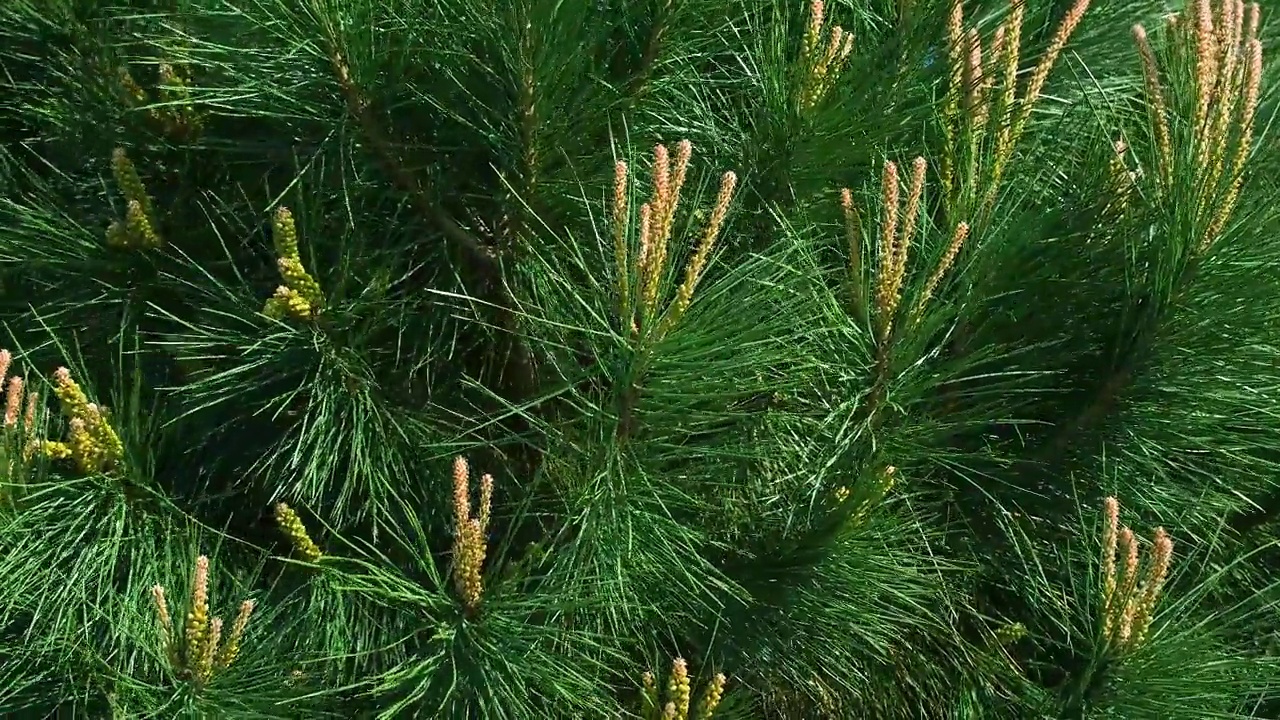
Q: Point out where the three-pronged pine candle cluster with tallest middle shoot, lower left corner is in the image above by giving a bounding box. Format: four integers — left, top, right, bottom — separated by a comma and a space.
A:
151, 555, 255, 687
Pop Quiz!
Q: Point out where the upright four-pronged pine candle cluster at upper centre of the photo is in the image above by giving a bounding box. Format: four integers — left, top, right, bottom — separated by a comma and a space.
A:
613, 140, 737, 340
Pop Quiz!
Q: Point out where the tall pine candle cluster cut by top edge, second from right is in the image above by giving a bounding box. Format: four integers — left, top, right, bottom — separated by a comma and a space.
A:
942, 0, 1089, 214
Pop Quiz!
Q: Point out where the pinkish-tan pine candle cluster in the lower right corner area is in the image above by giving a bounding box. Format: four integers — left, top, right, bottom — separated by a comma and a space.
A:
1102, 497, 1174, 653
